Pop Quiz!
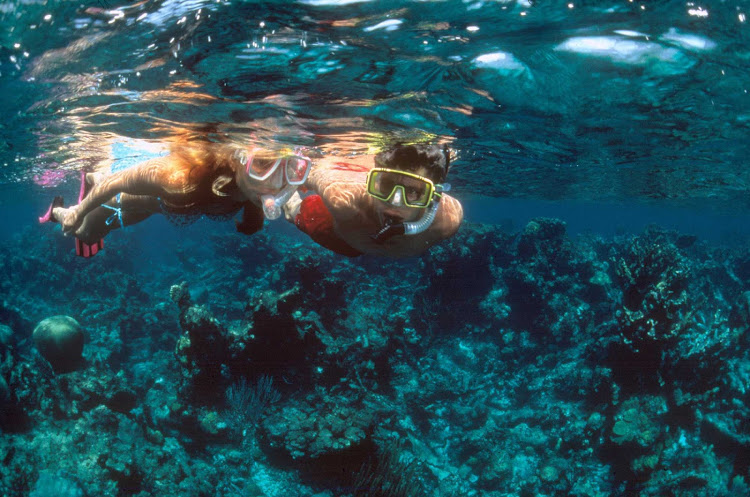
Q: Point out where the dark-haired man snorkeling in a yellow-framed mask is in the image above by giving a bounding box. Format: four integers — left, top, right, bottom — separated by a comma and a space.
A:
284, 144, 463, 257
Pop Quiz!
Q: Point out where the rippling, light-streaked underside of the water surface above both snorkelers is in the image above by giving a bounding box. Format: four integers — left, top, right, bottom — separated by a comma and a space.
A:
0, 1, 750, 209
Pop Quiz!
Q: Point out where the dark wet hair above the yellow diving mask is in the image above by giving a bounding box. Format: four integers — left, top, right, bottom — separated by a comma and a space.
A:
375, 143, 451, 183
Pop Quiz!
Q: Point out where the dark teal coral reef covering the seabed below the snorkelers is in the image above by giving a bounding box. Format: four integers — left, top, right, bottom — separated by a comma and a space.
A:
0, 219, 750, 497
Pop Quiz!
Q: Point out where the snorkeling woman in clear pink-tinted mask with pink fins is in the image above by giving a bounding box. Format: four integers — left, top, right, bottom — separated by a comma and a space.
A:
39, 143, 311, 257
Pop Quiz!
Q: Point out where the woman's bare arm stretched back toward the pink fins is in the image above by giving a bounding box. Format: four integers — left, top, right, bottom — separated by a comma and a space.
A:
62, 156, 190, 233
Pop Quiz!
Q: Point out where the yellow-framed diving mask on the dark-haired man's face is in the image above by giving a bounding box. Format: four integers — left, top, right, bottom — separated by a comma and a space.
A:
367, 168, 435, 207
